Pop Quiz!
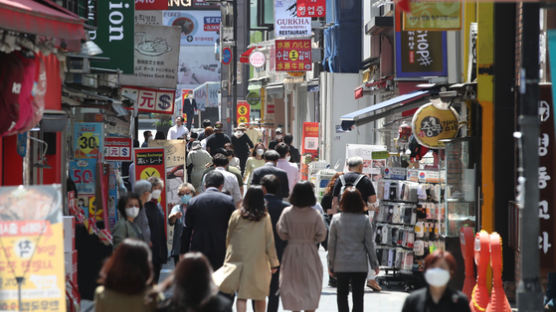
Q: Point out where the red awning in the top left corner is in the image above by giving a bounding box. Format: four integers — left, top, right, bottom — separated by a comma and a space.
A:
0, 0, 85, 41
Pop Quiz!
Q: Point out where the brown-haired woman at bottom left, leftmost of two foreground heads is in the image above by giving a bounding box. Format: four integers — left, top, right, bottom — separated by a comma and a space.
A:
95, 239, 156, 312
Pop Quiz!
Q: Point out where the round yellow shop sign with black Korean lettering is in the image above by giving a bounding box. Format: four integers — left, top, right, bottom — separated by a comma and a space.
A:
411, 103, 459, 149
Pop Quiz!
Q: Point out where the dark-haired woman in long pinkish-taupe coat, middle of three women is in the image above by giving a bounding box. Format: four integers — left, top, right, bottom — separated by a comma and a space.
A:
277, 181, 326, 311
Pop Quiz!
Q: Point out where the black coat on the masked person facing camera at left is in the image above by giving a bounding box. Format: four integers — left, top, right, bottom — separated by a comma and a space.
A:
144, 200, 168, 264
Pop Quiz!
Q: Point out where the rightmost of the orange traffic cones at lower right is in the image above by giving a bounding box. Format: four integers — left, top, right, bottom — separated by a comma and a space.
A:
487, 232, 512, 312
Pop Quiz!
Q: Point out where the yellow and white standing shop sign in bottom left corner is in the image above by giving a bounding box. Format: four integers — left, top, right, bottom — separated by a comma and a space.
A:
0, 184, 66, 311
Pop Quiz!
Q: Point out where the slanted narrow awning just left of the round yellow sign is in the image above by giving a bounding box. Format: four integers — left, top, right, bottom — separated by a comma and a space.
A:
340, 91, 429, 130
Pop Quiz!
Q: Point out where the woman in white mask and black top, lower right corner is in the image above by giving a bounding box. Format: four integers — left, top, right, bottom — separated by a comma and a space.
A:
402, 250, 471, 312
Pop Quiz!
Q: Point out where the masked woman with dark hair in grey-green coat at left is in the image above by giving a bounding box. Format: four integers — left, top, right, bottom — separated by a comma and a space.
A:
112, 193, 144, 249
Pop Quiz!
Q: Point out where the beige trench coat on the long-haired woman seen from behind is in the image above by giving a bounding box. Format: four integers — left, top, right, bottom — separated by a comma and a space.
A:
224, 209, 280, 300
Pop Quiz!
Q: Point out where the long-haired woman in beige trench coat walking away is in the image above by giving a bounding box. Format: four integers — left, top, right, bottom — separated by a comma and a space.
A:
218, 186, 280, 312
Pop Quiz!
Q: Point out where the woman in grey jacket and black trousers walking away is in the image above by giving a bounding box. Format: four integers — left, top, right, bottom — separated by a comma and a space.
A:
328, 187, 379, 312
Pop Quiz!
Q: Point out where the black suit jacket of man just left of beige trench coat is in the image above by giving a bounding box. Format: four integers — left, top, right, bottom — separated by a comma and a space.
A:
185, 187, 235, 271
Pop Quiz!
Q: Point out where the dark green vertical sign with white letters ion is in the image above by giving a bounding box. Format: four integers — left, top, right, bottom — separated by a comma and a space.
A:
89, 0, 135, 74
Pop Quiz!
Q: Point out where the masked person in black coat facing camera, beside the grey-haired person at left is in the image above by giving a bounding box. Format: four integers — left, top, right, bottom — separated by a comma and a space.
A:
145, 177, 168, 284
